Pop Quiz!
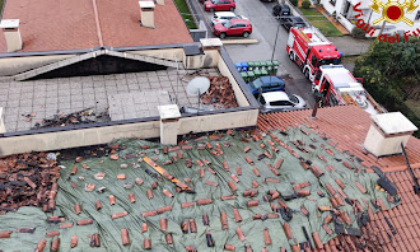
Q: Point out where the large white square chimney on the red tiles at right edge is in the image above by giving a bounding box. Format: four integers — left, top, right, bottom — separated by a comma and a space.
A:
363, 112, 418, 157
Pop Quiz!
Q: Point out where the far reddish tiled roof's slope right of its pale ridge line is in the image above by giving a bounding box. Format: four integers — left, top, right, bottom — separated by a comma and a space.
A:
98, 0, 193, 48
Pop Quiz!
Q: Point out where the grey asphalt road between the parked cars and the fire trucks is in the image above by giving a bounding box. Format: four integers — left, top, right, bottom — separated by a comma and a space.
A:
190, 0, 315, 108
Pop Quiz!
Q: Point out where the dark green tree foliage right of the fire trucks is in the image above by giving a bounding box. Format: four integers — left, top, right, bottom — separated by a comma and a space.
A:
354, 36, 420, 137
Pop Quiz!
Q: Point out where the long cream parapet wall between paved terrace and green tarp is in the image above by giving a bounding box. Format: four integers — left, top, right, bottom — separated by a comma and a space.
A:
0, 109, 258, 156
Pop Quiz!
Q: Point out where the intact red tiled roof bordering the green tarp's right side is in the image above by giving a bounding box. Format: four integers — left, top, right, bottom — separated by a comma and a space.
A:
258, 106, 420, 251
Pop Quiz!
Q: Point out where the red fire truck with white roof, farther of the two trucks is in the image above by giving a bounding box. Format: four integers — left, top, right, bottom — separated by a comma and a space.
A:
286, 27, 341, 81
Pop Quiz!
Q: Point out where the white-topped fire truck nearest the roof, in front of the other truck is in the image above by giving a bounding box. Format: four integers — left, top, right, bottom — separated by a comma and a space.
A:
312, 65, 384, 114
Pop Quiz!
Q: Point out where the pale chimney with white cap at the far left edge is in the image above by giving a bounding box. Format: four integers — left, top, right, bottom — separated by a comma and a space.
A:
0, 19, 23, 52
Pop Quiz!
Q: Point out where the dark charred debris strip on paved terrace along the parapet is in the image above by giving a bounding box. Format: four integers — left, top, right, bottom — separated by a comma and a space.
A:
31, 108, 109, 129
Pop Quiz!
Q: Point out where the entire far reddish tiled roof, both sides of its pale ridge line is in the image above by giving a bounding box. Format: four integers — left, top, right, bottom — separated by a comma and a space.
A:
0, 0, 192, 53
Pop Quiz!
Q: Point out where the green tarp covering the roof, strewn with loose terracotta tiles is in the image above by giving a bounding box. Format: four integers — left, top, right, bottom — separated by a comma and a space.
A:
0, 127, 399, 251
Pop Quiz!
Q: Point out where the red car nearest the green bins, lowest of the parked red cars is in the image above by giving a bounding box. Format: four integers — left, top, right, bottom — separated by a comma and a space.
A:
213, 19, 252, 39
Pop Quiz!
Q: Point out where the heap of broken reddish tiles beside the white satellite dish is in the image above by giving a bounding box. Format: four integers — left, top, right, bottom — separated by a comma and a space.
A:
201, 76, 238, 108
